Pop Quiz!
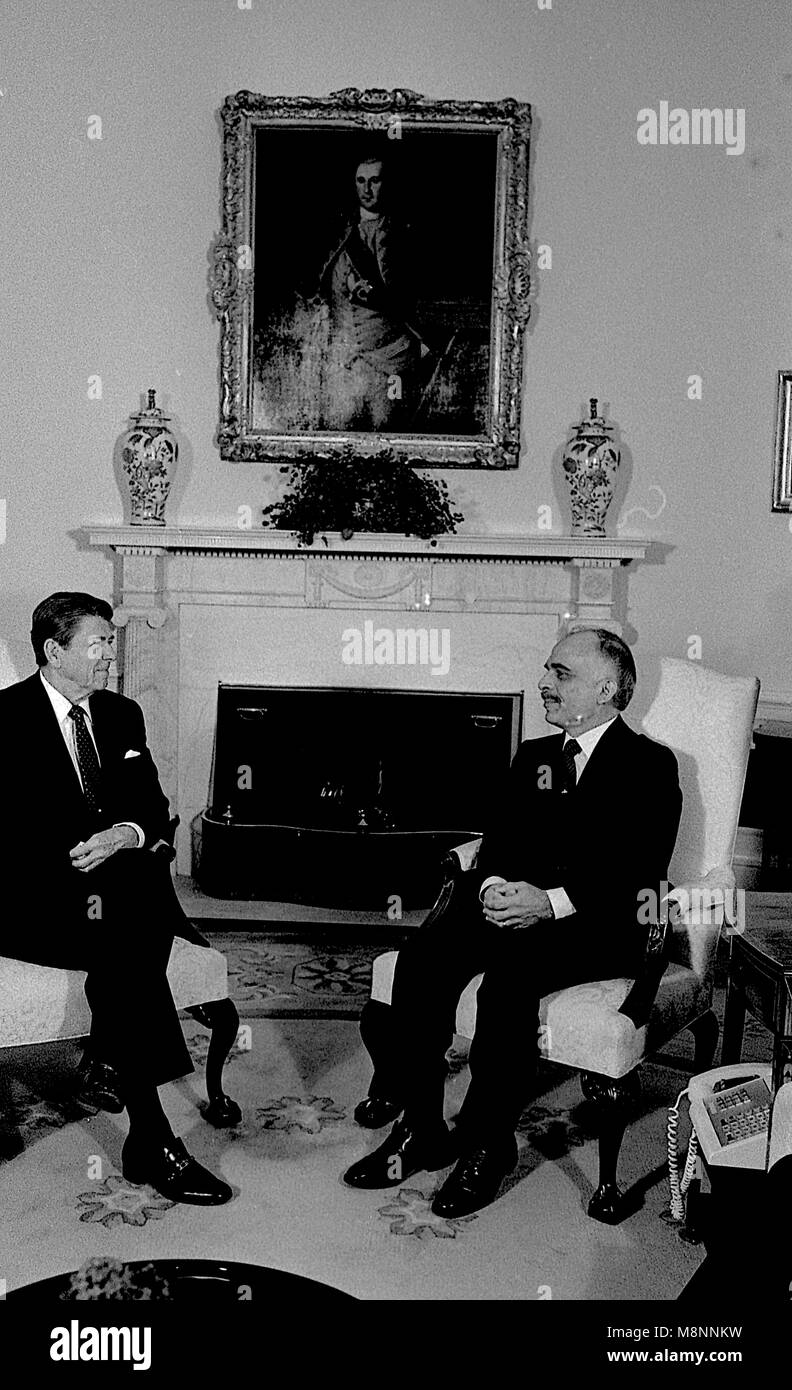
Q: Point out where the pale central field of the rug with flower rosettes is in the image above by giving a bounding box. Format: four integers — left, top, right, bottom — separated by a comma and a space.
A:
0, 1017, 703, 1301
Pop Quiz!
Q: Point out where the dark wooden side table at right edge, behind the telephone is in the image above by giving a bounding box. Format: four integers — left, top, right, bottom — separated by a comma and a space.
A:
721, 892, 792, 1091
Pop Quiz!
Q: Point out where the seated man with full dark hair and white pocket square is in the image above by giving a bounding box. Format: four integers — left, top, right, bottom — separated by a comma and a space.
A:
0, 594, 232, 1205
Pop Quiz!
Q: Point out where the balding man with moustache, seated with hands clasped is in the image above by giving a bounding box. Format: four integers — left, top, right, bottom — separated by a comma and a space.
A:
345, 628, 682, 1218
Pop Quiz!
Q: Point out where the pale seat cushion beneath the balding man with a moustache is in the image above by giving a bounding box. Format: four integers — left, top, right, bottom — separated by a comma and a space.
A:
371, 951, 711, 1079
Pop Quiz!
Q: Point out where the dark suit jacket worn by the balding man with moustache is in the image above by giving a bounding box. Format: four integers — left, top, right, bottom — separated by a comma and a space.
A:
477, 717, 682, 929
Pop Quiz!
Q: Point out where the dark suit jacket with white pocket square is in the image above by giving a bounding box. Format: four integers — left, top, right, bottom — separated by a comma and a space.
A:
0, 671, 170, 911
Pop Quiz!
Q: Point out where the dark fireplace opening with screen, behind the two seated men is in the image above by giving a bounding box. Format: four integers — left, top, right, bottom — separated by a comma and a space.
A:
193, 684, 522, 920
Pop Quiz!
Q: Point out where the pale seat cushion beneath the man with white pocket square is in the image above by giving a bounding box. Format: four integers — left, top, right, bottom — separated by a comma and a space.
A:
0, 937, 228, 1047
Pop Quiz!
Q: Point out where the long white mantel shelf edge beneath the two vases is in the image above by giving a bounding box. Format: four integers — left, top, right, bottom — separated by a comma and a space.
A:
82, 525, 653, 569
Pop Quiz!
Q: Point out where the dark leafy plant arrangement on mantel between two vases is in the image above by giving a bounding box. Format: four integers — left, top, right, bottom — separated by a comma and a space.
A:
261, 450, 464, 545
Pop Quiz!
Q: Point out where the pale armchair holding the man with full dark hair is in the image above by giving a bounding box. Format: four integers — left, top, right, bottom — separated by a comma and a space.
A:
0, 641, 242, 1158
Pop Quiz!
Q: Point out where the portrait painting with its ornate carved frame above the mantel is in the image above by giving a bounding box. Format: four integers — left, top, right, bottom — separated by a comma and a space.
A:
211, 88, 531, 468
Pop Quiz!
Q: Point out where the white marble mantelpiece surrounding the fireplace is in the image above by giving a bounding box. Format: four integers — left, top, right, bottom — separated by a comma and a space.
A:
82, 525, 652, 873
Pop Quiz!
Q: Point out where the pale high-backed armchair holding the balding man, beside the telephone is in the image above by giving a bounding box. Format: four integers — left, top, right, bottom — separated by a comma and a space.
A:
364, 657, 759, 1225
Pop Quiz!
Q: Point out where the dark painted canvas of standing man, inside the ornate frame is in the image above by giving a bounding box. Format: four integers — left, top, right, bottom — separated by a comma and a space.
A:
250, 126, 497, 438
